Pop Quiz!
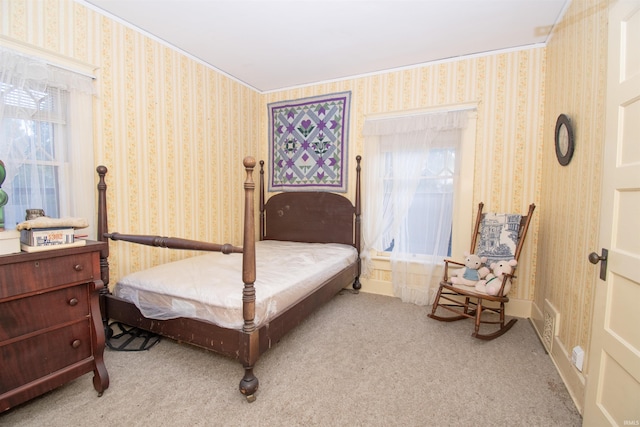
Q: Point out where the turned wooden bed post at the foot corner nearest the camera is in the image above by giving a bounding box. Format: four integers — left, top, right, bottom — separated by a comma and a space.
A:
240, 157, 260, 402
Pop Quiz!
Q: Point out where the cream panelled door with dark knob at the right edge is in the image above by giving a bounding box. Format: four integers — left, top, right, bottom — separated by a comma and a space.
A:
583, 0, 640, 426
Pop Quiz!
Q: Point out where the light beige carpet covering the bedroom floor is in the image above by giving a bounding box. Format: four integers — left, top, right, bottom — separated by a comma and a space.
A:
0, 292, 582, 427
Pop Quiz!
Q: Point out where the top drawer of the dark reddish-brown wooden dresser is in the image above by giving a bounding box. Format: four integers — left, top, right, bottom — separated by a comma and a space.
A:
0, 251, 94, 299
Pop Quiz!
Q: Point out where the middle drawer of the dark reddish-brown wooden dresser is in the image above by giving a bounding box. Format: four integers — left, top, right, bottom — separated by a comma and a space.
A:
0, 284, 90, 342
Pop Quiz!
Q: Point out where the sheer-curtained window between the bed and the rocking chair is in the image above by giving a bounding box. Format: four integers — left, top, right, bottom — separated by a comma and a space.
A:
362, 107, 475, 305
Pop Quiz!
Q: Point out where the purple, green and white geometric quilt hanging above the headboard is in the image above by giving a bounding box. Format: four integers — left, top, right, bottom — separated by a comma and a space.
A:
268, 92, 351, 193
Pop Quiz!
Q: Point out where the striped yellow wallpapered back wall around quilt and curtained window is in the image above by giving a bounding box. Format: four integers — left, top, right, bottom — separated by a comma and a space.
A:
260, 48, 545, 304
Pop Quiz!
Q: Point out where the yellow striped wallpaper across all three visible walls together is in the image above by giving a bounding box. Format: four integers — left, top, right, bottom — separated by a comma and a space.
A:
0, 0, 607, 412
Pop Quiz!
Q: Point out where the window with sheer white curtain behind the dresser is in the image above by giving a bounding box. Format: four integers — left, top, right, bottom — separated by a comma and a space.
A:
0, 48, 95, 237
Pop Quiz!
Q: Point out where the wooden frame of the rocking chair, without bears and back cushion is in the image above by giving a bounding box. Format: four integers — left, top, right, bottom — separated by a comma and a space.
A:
428, 203, 535, 340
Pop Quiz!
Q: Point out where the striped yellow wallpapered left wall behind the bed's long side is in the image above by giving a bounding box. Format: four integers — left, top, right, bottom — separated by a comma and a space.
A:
0, 0, 264, 283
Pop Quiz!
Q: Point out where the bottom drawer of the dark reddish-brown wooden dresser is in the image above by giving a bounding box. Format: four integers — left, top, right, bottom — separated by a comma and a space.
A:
0, 319, 92, 394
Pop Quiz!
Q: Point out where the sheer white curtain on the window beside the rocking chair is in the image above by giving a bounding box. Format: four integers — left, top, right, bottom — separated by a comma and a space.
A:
362, 111, 468, 305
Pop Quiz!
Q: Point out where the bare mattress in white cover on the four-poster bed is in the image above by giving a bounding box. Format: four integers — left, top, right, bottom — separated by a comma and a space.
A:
113, 240, 358, 329
